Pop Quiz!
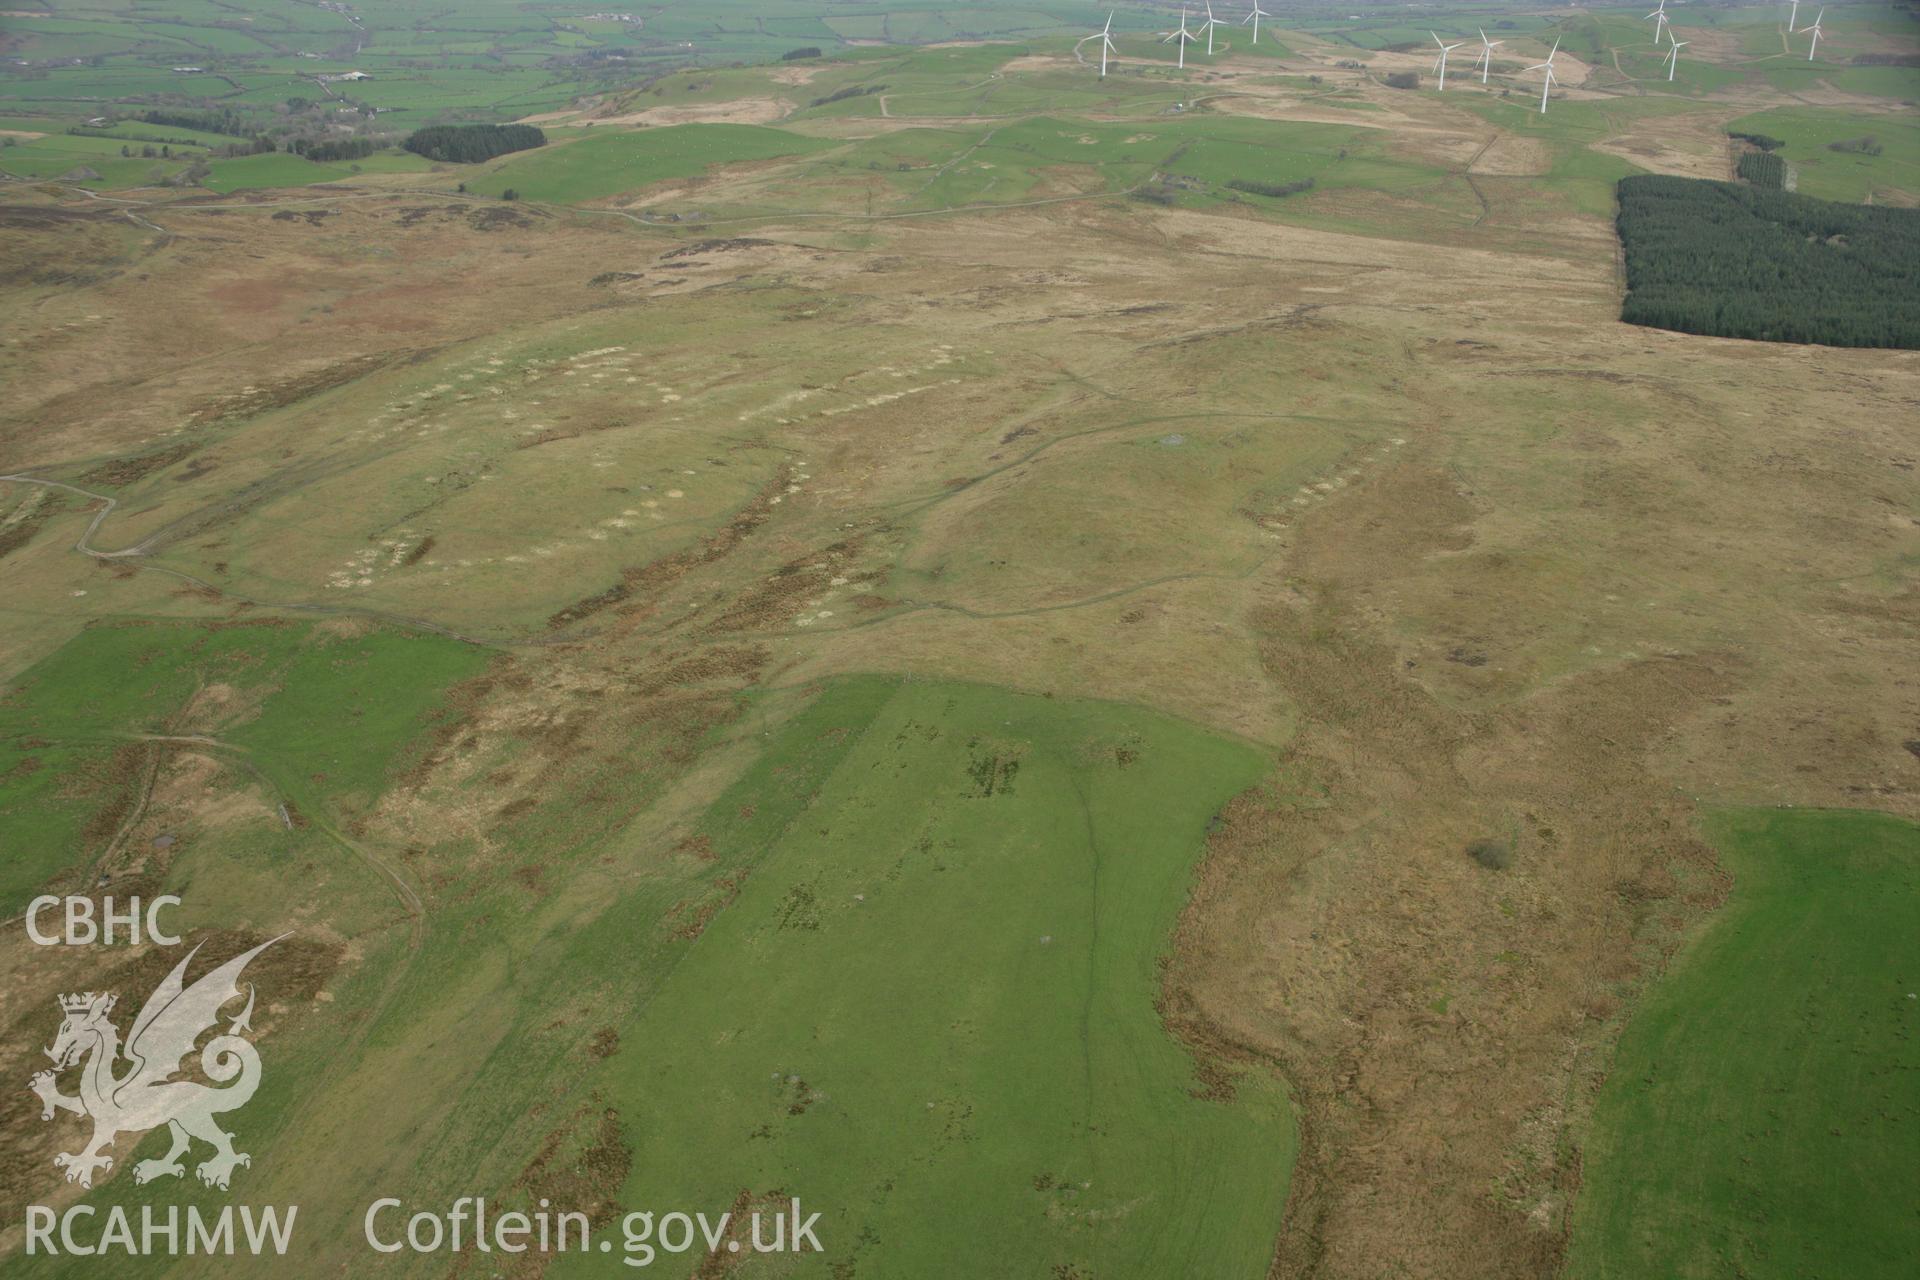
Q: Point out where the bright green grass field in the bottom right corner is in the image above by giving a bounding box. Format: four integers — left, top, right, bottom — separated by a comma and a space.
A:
1569, 810, 1920, 1280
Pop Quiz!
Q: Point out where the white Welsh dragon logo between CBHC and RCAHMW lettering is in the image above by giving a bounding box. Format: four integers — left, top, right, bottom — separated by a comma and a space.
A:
33, 935, 286, 1190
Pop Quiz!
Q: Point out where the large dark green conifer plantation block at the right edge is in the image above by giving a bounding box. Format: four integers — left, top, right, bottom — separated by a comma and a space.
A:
1617, 175, 1920, 349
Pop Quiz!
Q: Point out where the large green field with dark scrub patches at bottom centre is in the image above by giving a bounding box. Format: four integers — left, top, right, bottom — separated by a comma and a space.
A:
563, 679, 1294, 1276
